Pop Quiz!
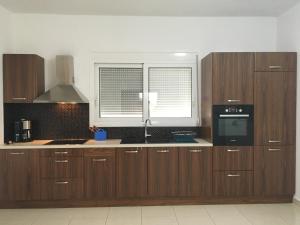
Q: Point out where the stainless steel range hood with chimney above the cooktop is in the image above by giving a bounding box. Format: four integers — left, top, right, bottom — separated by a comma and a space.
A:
33, 55, 88, 104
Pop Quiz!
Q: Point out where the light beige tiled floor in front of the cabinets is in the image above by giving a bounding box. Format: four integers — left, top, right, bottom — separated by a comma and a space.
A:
0, 204, 300, 225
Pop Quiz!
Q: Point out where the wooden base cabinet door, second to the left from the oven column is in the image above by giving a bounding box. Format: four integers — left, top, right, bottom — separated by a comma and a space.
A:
148, 148, 178, 197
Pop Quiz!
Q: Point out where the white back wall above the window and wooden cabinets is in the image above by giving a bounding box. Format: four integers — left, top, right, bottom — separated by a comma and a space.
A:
13, 14, 276, 96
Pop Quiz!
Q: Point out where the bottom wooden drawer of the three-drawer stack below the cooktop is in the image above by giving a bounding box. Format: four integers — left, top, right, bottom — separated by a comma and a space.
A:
41, 179, 84, 200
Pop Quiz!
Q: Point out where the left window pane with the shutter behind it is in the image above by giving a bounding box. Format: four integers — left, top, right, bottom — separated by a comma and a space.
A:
99, 67, 143, 117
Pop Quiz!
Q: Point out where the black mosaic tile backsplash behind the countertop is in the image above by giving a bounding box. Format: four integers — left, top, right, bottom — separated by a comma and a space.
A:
4, 103, 200, 142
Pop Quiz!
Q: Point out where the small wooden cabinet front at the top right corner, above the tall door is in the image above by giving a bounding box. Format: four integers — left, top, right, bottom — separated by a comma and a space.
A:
255, 52, 297, 72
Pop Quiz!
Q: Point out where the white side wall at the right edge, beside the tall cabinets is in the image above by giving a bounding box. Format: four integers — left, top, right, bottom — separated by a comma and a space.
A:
277, 3, 300, 201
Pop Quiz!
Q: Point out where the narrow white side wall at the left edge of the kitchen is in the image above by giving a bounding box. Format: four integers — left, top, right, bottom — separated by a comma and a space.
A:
0, 6, 11, 144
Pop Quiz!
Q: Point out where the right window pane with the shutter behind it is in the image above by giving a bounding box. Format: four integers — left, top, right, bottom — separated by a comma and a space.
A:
149, 68, 192, 117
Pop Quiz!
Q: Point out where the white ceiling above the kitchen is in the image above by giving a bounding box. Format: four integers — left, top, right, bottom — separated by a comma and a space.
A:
0, 0, 300, 16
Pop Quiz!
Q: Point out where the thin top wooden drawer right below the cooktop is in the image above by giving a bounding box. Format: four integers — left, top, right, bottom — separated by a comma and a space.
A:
40, 148, 83, 158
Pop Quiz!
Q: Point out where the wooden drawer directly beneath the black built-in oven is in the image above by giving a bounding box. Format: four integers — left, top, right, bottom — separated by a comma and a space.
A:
213, 146, 253, 170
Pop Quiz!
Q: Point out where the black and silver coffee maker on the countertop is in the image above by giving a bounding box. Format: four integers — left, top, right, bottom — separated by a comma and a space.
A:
14, 119, 32, 142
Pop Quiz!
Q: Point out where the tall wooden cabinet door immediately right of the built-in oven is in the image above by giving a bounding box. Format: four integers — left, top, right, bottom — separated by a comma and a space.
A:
254, 72, 296, 145
